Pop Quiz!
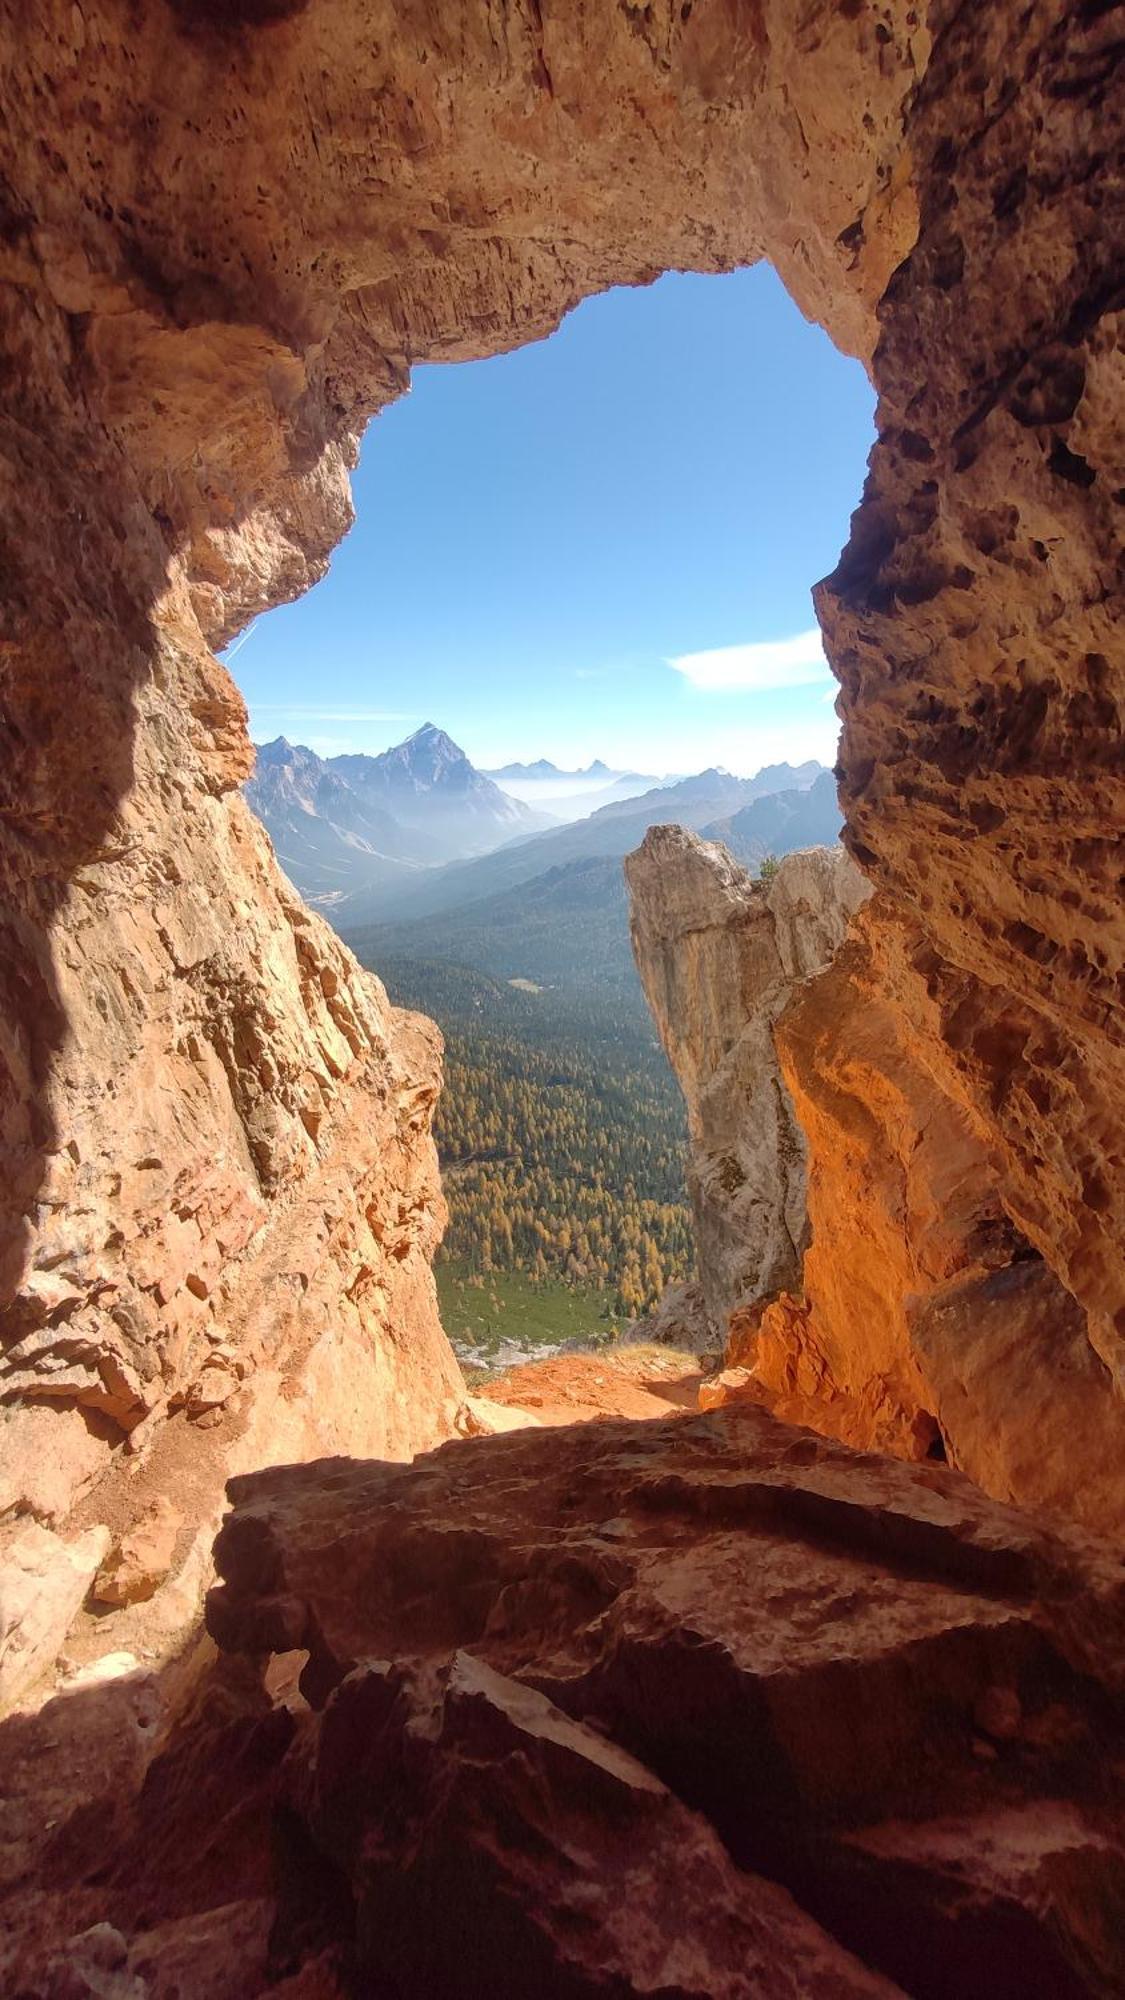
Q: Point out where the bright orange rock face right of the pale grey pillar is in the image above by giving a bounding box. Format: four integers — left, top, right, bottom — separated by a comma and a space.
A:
748, 900, 1125, 1528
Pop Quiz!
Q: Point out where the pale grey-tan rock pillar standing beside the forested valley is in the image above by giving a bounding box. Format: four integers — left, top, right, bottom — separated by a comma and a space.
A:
625, 826, 871, 1346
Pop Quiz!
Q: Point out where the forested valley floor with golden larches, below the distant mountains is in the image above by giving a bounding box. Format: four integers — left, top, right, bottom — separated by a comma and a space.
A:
350, 932, 693, 1332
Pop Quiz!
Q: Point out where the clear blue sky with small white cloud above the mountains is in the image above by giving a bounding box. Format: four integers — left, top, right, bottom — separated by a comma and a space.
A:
228, 264, 875, 774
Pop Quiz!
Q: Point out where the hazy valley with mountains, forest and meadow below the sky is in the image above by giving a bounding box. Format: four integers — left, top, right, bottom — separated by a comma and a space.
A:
246, 724, 839, 1364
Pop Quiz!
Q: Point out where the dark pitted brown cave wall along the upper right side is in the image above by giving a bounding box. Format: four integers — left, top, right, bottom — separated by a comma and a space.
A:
817, 6, 1125, 1390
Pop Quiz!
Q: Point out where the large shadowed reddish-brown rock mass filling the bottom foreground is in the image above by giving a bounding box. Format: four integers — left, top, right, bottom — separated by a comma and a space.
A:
0, 1410, 1125, 2000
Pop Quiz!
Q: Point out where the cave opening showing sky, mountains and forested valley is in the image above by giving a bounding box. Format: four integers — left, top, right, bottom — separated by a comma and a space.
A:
226, 262, 875, 1370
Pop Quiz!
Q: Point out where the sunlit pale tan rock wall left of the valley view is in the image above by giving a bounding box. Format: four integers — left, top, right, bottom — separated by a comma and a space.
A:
0, 872, 462, 1672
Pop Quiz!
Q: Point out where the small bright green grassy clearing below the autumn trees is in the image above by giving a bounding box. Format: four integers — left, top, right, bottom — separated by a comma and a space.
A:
434, 1262, 625, 1366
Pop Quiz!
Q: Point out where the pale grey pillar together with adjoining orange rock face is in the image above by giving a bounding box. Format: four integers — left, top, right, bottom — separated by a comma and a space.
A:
627, 826, 1125, 1528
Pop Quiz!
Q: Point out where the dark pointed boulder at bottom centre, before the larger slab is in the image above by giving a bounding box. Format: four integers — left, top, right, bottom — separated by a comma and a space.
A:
290, 1650, 895, 2000
